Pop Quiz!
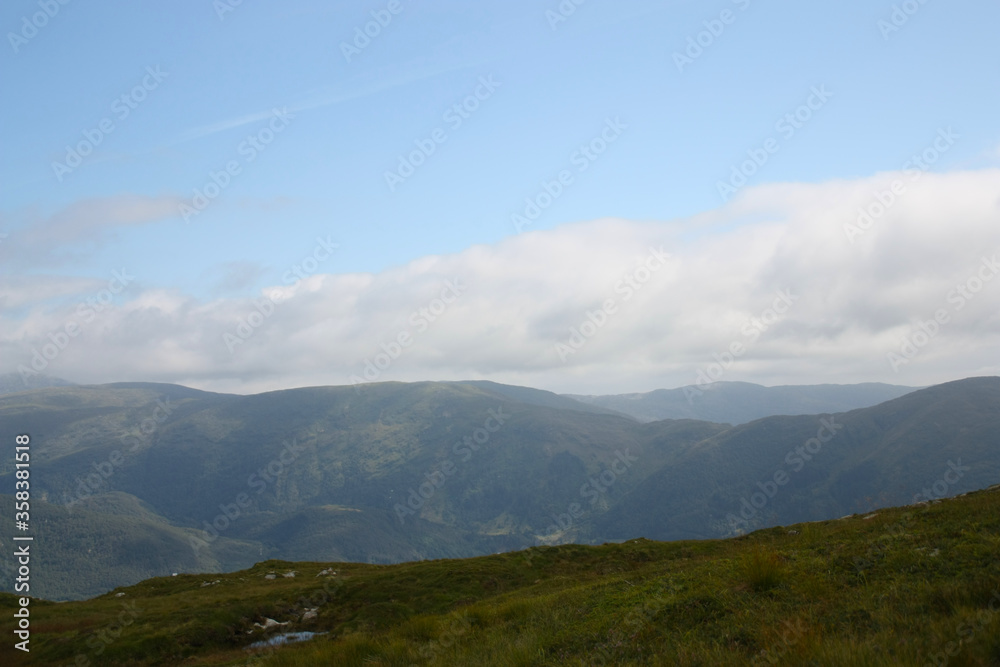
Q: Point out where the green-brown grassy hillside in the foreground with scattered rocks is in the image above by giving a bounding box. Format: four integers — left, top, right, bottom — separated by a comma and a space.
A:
7, 487, 1000, 667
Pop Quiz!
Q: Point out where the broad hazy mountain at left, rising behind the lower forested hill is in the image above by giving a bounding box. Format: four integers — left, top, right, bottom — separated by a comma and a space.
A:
0, 383, 724, 600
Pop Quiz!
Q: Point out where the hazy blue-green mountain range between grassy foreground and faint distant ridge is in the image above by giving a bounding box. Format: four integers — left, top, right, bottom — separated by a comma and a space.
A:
0, 377, 1000, 599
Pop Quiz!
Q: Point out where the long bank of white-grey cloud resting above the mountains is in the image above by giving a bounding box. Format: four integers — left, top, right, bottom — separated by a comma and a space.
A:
0, 169, 1000, 393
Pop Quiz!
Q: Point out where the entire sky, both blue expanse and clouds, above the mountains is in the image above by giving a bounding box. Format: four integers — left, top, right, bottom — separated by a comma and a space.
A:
0, 0, 1000, 394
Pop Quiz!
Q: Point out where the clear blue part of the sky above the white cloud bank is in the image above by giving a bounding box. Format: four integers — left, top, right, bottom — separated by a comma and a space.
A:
0, 0, 1000, 390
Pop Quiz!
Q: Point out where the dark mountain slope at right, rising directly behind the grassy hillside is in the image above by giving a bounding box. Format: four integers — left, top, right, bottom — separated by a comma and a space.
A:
593, 377, 1000, 539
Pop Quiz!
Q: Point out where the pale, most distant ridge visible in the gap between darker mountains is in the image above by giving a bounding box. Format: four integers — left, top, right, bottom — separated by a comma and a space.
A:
566, 382, 916, 424
